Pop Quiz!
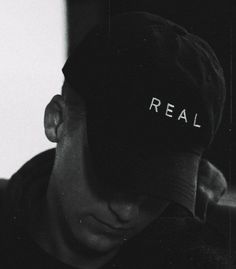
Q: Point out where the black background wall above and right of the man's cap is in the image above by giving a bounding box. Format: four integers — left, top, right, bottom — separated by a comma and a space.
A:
67, 0, 233, 186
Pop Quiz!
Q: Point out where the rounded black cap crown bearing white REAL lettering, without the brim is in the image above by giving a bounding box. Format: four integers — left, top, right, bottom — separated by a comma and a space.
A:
63, 12, 225, 154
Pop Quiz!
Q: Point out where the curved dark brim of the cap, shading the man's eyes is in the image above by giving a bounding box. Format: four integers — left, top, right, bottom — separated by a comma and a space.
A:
87, 112, 200, 214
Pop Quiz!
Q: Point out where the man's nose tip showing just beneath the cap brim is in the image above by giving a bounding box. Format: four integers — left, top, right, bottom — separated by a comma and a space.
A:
109, 195, 141, 223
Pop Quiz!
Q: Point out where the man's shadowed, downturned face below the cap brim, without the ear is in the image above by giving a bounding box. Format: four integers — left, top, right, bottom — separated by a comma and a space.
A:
48, 100, 168, 253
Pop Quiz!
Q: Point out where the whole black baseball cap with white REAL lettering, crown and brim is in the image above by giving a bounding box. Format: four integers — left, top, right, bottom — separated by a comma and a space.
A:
63, 12, 225, 214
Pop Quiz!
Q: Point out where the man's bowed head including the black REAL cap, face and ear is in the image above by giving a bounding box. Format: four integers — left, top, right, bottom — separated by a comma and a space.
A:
45, 13, 225, 251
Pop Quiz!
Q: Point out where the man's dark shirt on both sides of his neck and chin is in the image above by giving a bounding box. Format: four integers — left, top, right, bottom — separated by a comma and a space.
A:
0, 150, 233, 269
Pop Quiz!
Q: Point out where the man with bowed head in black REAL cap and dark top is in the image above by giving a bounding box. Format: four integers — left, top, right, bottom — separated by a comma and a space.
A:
1, 12, 232, 269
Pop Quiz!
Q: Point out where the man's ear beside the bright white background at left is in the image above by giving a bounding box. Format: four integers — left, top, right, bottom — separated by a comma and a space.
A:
44, 95, 65, 142
